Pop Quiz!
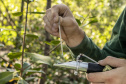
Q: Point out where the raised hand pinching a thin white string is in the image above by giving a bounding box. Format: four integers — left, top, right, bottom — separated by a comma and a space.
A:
43, 4, 84, 47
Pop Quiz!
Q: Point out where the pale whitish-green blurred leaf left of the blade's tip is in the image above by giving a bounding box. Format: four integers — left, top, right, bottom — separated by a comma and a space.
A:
26, 52, 51, 65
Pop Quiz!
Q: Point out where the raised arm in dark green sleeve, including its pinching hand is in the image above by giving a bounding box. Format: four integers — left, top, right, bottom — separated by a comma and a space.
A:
43, 4, 126, 61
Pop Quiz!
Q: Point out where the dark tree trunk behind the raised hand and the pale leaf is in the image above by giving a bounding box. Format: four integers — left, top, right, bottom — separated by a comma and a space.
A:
40, 0, 51, 84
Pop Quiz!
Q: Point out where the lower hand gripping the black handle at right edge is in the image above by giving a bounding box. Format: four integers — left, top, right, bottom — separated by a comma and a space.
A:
87, 56, 126, 84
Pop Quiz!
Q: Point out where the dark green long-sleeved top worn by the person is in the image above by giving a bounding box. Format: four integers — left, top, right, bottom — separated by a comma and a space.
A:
70, 7, 126, 61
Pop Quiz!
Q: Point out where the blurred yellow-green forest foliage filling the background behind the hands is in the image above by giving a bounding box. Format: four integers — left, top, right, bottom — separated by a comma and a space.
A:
0, 0, 126, 84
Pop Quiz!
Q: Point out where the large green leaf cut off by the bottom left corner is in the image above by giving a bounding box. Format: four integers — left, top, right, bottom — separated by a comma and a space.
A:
0, 72, 13, 84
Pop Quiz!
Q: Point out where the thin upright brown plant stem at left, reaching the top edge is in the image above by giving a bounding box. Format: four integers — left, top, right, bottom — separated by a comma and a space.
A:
21, 0, 29, 77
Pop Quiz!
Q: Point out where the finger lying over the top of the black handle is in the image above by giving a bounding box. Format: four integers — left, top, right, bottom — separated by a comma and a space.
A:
99, 56, 126, 67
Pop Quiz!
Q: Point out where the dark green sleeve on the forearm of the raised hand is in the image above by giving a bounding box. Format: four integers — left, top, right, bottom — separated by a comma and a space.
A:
70, 35, 105, 61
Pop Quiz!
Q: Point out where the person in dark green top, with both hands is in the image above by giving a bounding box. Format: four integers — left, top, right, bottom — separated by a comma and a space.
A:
43, 4, 126, 84
